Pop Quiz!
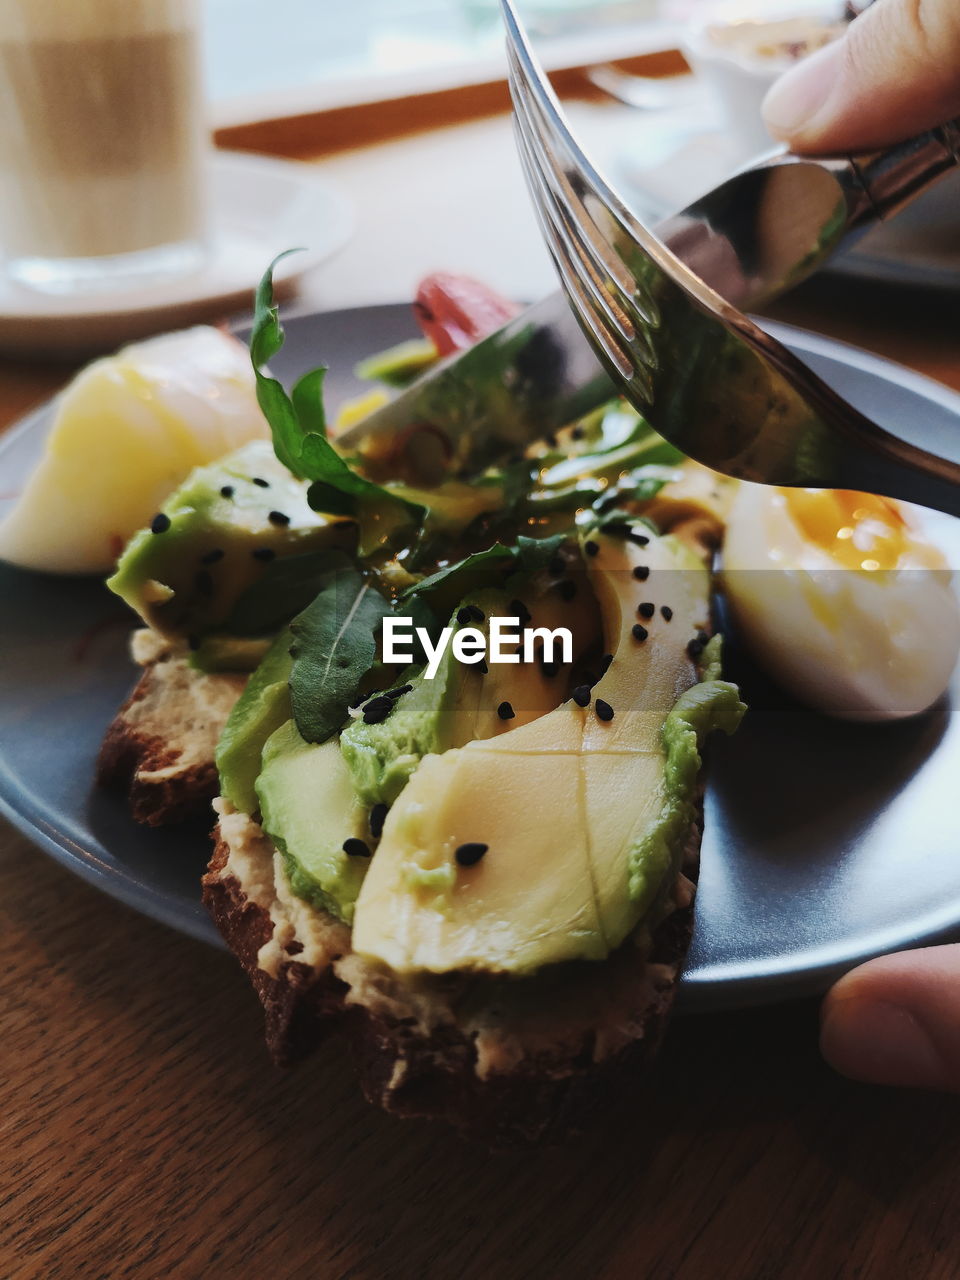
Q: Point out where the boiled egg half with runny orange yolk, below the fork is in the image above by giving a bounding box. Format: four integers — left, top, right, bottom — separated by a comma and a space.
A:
722, 484, 960, 721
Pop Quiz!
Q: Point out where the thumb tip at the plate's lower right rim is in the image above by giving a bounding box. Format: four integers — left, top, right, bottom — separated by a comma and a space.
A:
820, 945, 960, 1092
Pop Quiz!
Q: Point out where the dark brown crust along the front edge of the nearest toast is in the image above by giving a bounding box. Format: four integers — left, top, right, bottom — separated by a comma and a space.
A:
204, 803, 700, 1147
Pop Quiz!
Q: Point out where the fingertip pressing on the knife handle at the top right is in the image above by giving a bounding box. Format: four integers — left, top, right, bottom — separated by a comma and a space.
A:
763, 0, 960, 155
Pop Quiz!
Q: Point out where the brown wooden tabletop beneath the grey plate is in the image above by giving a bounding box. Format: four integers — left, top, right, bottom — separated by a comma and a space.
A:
0, 94, 960, 1280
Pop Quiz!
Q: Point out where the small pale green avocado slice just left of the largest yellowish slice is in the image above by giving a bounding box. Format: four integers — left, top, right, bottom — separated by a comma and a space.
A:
256, 719, 371, 924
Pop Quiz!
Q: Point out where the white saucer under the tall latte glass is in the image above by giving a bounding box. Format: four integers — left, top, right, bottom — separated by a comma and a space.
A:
0, 151, 353, 356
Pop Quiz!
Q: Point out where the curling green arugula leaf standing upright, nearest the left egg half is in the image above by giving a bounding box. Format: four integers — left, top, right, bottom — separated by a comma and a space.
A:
250, 257, 424, 554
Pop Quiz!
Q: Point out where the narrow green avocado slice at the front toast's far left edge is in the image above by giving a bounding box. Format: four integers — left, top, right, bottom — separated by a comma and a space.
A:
216, 627, 293, 813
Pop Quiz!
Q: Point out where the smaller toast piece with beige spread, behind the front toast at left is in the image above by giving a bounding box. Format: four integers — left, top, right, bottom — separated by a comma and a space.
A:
97, 628, 247, 827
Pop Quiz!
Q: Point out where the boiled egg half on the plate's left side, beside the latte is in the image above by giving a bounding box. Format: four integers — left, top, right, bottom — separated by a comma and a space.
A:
0, 325, 270, 573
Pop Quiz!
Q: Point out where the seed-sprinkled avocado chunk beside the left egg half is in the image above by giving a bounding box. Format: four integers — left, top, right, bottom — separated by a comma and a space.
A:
106, 440, 356, 637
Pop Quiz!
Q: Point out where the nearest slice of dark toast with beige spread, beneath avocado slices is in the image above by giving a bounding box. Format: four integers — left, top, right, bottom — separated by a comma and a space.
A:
204, 800, 700, 1146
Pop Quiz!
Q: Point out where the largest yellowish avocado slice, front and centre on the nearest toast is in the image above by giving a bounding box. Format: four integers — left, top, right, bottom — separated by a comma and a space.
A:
353, 530, 744, 975
